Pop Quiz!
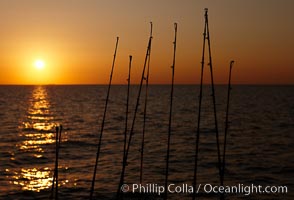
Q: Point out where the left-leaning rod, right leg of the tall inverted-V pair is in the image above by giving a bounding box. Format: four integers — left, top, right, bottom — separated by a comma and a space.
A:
205, 8, 221, 183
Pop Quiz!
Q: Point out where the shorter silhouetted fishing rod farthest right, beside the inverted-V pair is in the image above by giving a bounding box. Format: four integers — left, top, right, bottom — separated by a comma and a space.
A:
221, 60, 234, 188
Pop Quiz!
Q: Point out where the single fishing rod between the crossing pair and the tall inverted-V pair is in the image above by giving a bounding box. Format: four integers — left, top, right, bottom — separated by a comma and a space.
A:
164, 23, 178, 199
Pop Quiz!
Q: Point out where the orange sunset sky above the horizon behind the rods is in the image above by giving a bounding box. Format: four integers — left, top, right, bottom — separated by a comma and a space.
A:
0, 0, 294, 84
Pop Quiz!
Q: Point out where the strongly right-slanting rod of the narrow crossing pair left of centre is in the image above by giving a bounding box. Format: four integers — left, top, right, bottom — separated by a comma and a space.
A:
117, 24, 152, 198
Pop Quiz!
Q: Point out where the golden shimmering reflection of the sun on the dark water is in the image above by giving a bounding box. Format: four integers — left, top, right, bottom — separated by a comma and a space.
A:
11, 86, 66, 192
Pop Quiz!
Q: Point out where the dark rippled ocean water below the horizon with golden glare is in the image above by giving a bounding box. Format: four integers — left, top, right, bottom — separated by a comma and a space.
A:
0, 85, 294, 200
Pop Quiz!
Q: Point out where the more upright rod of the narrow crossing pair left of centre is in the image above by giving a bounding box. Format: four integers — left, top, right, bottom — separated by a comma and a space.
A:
140, 22, 152, 183
